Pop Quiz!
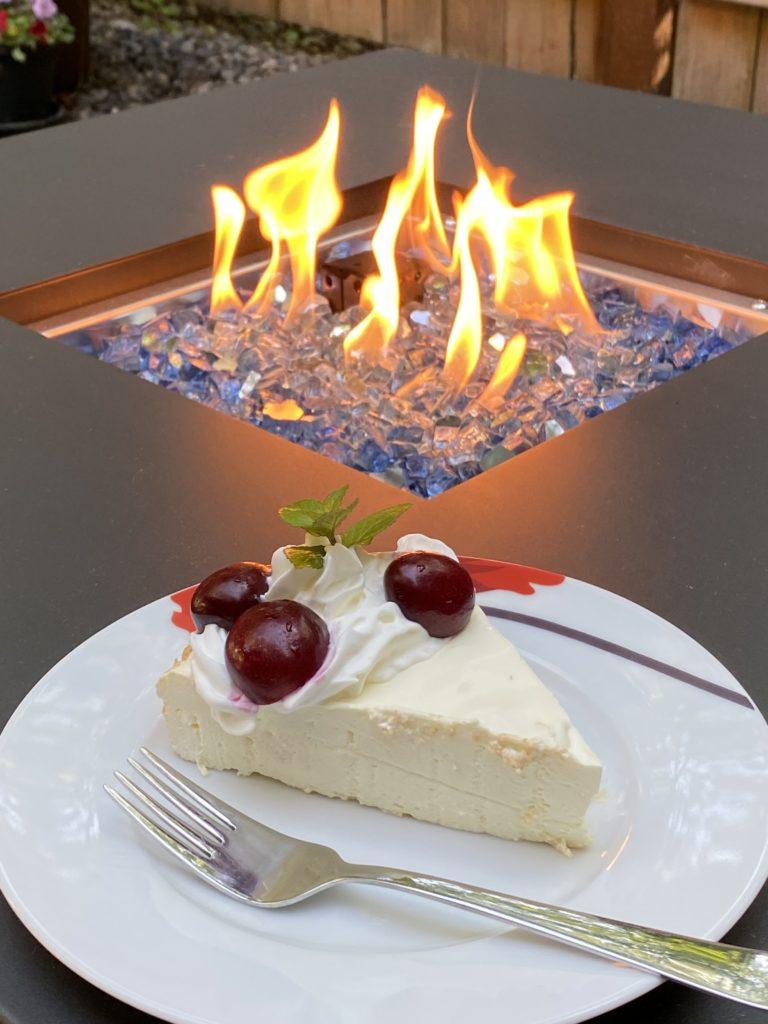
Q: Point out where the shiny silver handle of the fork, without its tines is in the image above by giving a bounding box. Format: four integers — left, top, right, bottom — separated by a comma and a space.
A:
344, 864, 768, 1009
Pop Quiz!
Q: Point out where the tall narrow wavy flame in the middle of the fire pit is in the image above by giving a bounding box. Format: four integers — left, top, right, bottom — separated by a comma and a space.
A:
344, 86, 449, 360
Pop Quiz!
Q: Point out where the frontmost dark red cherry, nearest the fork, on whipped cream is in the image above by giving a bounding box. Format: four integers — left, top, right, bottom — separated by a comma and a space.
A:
224, 601, 330, 705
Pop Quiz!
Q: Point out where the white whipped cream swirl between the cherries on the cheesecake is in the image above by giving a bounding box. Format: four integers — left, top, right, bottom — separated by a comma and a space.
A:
190, 534, 456, 735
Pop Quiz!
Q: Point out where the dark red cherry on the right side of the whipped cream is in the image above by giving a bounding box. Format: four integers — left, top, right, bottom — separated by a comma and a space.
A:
384, 551, 475, 637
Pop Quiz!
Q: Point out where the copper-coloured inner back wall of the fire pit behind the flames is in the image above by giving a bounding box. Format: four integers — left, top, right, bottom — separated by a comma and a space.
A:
0, 178, 768, 324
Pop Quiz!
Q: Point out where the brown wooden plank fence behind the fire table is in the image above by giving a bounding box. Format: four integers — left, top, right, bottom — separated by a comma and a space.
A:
224, 0, 768, 113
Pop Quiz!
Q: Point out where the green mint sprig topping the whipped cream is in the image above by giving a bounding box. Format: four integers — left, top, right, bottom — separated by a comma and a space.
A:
280, 486, 411, 569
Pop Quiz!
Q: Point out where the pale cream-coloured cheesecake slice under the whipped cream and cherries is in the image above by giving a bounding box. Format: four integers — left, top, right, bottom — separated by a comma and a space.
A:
158, 608, 601, 851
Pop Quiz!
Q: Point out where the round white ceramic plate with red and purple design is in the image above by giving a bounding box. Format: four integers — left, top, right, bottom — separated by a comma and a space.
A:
0, 560, 768, 1024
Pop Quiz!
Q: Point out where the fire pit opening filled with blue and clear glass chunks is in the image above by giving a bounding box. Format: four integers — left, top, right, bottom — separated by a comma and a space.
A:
36, 198, 768, 497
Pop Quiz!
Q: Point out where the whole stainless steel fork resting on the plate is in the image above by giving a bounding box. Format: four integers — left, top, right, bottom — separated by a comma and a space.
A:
104, 748, 768, 1009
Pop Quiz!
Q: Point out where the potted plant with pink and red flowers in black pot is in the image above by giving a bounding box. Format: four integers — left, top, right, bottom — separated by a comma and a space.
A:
0, 0, 75, 125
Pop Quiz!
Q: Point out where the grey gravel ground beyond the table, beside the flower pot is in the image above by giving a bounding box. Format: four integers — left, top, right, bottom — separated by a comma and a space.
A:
71, 0, 376, 118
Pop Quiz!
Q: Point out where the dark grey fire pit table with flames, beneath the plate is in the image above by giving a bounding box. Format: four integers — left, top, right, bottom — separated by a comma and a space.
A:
0, 50, 768, 1024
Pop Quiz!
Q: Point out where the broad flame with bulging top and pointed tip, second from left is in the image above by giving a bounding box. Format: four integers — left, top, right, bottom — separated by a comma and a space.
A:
243, 99, 342, 323
